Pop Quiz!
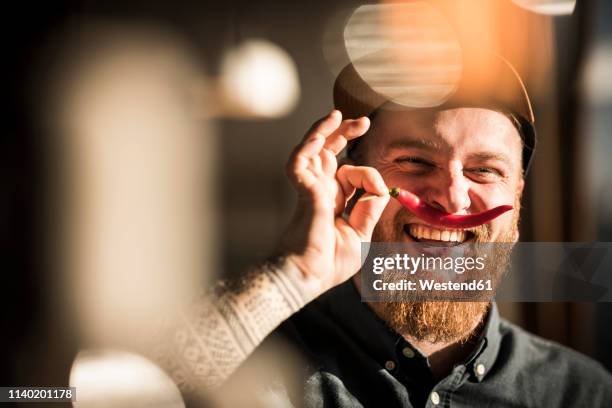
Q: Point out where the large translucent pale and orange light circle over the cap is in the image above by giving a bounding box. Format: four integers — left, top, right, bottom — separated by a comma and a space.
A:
344, 2, 462, 107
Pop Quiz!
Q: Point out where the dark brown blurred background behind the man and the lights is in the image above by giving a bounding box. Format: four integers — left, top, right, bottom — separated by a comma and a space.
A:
0, 0, 612, 385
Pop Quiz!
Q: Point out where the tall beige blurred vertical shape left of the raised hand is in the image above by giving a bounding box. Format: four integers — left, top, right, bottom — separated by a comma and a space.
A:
45, 22, 218, 349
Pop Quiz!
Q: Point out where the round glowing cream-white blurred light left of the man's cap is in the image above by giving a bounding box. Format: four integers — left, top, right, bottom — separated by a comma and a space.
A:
219, 40, 300, 118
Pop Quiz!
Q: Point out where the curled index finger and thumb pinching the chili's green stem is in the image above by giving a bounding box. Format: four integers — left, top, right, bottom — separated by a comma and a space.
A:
336, 165, 389, 240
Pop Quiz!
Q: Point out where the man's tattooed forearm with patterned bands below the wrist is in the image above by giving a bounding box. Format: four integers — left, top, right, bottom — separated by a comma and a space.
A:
155, 261, 312, 394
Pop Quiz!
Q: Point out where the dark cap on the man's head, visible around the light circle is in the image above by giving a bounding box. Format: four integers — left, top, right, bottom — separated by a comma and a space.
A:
334, 54, 536, 174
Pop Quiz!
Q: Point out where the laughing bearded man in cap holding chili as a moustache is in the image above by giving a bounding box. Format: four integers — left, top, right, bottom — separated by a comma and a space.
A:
157, 61, 612, 407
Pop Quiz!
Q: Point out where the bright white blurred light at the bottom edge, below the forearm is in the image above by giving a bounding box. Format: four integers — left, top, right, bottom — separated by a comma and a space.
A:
70, 350, 185, 408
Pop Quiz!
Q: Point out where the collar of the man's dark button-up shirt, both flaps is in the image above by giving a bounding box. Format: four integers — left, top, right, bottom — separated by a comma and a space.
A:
326, 279, 501, 382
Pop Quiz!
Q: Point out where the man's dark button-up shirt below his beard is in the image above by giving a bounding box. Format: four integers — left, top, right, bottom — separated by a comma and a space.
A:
264, 281, 612, 407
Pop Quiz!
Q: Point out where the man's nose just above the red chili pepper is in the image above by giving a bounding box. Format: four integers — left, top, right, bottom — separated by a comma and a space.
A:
426, 165, 471, 214
